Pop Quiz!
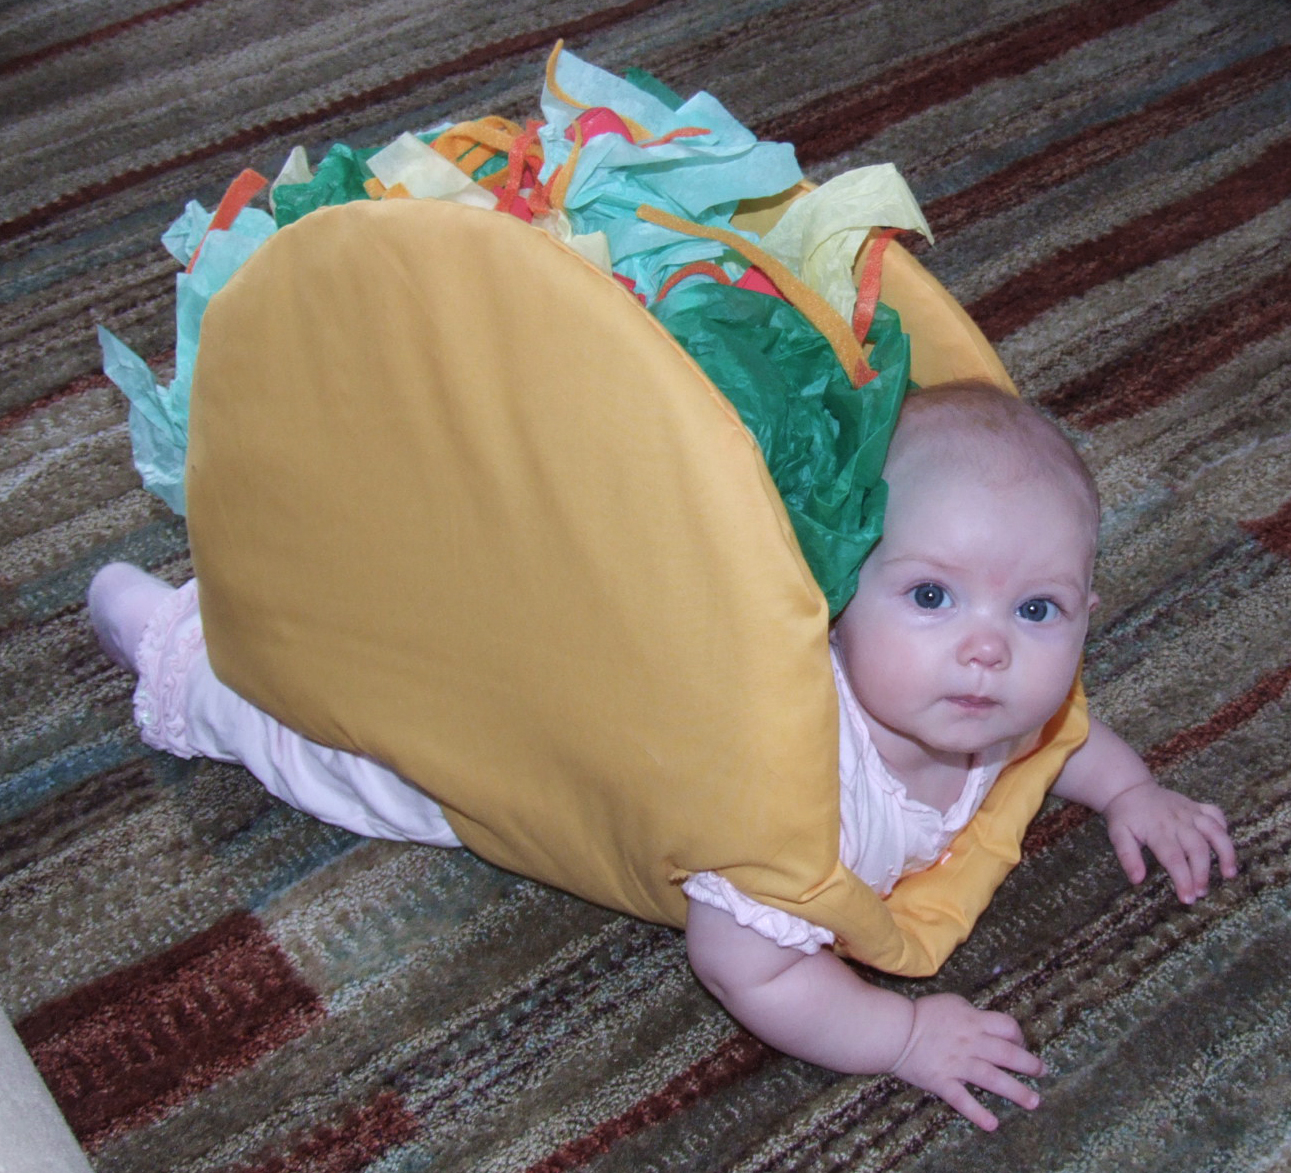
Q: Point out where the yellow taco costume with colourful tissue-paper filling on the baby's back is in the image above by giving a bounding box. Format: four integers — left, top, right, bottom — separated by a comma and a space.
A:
103, 45, 1087, 974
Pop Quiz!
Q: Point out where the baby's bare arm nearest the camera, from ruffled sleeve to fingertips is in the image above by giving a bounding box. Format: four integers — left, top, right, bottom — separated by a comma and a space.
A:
686, 901, 1044, 1132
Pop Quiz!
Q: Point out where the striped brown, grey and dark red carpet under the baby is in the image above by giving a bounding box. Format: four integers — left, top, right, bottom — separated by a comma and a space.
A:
0, 0, 1291, 1173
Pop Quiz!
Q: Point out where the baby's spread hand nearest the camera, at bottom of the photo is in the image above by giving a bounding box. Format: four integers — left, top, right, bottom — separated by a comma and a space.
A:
892, 994, 1044, 1132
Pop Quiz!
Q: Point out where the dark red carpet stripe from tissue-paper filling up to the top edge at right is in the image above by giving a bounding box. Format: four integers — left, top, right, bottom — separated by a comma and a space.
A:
757, 0, 1174, 168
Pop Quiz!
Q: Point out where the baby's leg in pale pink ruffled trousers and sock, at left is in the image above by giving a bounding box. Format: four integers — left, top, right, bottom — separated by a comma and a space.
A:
89, 563, 460, 847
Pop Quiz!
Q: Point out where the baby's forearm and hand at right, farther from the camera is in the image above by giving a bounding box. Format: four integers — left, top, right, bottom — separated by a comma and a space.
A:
1053, 717, 1237, 905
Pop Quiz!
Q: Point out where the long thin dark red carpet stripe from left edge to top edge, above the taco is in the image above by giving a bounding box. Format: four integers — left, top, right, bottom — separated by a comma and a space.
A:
0, 0, 671, 240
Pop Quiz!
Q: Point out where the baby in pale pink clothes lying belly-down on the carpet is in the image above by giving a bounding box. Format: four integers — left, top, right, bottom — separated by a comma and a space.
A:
89, 383, 1237, 1129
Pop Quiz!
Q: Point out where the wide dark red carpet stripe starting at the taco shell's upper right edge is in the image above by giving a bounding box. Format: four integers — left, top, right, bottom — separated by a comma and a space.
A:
964, 139, 1291, 341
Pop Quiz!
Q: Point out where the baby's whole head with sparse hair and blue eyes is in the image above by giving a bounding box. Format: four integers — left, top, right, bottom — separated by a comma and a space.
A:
835, 383, 1099, 757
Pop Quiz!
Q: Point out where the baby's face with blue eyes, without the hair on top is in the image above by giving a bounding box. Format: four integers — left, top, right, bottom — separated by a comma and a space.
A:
835, 470, 1096, 767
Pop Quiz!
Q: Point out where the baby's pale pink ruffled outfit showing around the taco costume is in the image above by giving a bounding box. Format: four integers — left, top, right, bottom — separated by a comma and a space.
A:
134, 582, 1007, 954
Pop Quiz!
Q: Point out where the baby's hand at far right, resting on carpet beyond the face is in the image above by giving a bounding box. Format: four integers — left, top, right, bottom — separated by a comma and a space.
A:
1103, 781, 1237, 905
